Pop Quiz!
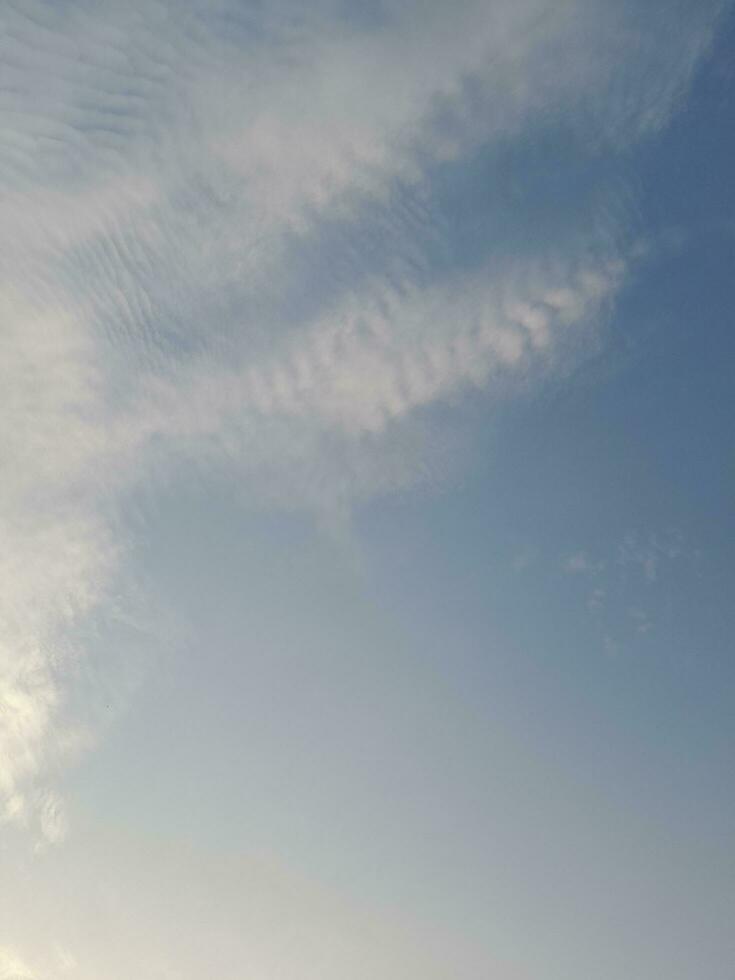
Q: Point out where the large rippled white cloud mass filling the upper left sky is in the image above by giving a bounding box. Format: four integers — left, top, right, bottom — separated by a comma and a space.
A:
0, 0, 721, 978
